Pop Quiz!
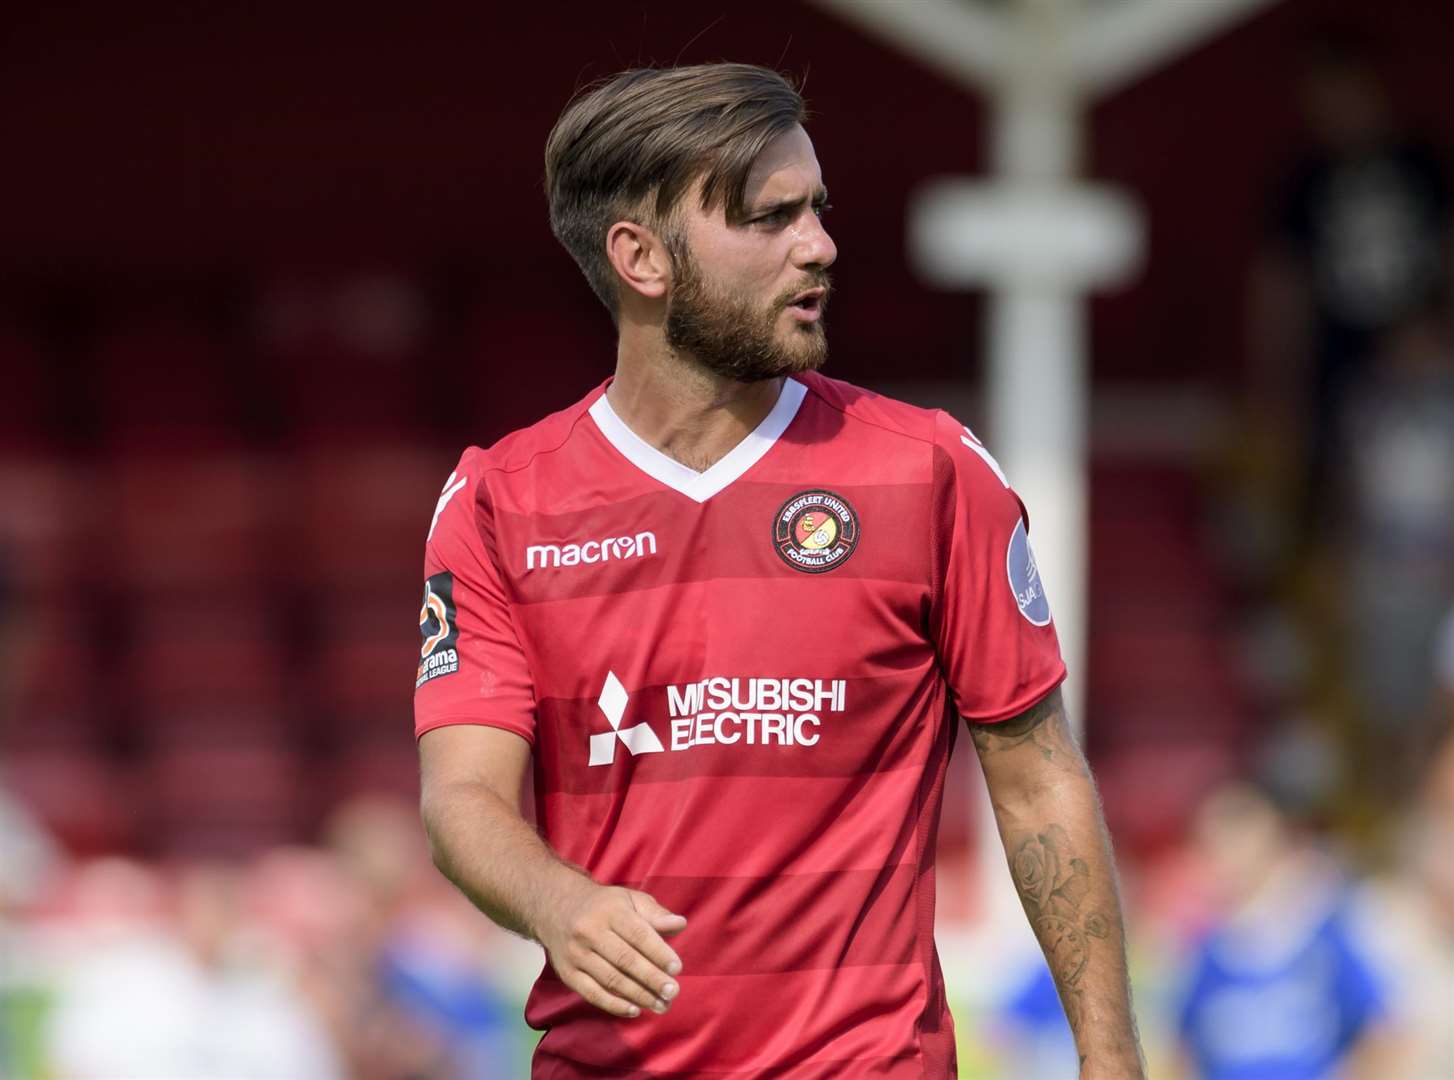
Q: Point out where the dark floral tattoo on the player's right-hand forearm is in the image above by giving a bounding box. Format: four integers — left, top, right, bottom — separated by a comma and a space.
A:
1011, 826, 1111, 1032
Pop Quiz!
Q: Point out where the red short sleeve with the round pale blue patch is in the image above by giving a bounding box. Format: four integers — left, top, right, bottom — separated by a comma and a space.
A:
931, 414, 1066, 722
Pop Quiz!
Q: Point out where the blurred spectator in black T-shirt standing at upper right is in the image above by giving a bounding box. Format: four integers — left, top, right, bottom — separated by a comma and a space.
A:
1253, 35, 1450, 540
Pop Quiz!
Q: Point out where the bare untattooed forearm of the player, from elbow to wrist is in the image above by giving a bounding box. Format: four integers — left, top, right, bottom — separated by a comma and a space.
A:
422, 783, 590, 940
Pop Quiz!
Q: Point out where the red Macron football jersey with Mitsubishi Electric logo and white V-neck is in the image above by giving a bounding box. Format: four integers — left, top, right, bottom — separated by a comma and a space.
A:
416, 374, 1064, 1077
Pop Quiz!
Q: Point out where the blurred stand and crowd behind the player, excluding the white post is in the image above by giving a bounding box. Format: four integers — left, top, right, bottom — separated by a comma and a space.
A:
0, 0, 1454, 1080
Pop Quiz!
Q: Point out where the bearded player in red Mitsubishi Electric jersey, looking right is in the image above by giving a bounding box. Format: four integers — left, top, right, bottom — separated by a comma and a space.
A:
416, 64, 1141, 1079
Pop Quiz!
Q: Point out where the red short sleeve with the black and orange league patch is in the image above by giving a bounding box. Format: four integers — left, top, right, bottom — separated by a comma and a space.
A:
414, 448, 535, 744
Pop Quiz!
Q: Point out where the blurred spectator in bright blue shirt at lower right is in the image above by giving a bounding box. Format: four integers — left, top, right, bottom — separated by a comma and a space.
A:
1179, 783, 1394, 1080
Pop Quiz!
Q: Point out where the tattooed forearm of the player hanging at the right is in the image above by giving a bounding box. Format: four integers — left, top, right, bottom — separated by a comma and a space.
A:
995, 762, 1144, 1077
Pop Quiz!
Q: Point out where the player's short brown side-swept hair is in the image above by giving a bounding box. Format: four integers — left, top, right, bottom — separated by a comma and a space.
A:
545, 64, 807, 318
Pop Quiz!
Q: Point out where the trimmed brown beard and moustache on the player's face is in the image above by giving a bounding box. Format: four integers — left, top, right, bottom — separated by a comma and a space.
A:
666, 246, 829, 382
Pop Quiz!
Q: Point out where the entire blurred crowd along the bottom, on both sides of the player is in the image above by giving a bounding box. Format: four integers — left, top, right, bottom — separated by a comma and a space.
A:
8, 720, 1454, 1080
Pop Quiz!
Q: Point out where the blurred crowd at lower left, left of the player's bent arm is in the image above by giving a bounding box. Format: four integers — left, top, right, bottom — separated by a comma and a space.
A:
0, 797, 538, 1080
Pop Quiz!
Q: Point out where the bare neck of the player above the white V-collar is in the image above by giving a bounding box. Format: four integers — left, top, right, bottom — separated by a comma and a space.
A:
606, 334, 782, 472
